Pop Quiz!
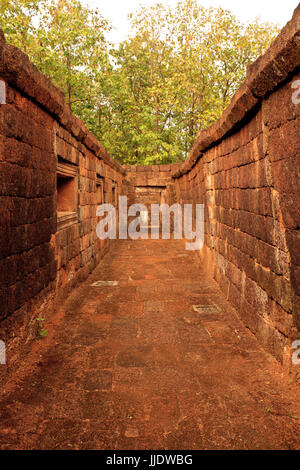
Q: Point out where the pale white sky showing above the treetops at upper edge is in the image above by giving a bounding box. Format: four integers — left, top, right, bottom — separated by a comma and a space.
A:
84, 0, 299, 42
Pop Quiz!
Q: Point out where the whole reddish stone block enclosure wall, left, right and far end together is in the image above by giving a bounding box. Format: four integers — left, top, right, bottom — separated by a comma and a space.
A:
0, 7, 300, 374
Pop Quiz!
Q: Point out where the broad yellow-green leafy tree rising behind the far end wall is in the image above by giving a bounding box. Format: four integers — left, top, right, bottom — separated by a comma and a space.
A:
104, 0, 278, 164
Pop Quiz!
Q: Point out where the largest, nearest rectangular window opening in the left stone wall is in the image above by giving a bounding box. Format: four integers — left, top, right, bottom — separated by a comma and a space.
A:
57, 160, 78, 230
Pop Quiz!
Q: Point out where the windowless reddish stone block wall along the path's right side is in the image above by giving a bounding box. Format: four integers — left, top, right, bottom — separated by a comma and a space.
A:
173, 7, 300, 370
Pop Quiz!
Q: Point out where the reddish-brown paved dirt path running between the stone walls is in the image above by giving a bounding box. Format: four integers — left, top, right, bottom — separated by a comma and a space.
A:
0, 240, 300, 449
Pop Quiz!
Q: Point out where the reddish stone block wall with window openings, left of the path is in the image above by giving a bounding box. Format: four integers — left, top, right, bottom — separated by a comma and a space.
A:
0, 32, 125, 348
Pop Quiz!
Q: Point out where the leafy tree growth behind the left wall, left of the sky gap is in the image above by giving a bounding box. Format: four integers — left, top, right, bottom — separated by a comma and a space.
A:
0, 0, 110, 137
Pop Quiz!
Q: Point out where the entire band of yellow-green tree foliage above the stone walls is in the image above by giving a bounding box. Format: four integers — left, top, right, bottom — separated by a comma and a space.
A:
0, 0, 278, 164
